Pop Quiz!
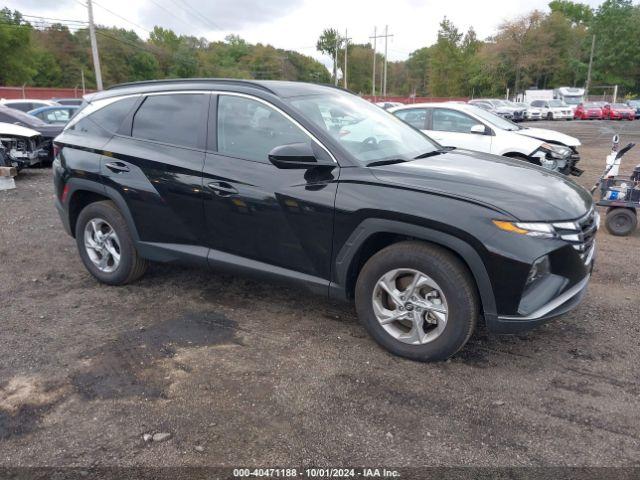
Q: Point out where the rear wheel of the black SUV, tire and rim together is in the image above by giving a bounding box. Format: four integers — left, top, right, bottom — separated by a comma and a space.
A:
76, 201, 147, 285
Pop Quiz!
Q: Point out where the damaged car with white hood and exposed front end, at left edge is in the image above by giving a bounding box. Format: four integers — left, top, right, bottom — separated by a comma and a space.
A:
0, 123, 48, 170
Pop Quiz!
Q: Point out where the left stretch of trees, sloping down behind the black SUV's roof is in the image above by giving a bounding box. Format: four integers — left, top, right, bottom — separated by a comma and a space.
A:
0, 8, 331, 88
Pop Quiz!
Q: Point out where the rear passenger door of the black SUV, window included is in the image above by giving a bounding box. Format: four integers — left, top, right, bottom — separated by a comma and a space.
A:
101, 92, 211, 249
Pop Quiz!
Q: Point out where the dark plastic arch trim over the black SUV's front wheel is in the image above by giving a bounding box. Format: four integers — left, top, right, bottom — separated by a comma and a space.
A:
329, 218, 497, 321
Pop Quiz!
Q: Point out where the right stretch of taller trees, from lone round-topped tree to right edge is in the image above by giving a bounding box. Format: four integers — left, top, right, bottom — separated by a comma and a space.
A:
317, 0, 640, 97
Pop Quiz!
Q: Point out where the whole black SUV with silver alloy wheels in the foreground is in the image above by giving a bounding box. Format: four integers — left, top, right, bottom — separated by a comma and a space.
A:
54, 79, 598, 360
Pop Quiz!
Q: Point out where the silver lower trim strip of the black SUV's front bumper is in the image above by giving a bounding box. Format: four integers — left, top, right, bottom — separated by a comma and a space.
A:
486, 274, 591, 334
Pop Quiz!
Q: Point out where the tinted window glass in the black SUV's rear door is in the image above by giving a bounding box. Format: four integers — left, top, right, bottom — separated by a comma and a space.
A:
131, 93, 209, 148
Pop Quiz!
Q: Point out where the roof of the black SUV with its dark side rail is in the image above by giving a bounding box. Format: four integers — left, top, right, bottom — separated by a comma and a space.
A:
92, 78, 346, 99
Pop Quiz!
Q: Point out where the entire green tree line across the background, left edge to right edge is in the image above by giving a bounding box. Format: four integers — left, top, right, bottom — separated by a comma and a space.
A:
0, 0, 640, 97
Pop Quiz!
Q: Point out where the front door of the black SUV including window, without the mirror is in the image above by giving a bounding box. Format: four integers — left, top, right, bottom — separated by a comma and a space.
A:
204, 93, 339, 285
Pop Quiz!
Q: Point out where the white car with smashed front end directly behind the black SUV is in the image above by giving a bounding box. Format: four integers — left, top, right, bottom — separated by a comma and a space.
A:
389, 103, 582, 175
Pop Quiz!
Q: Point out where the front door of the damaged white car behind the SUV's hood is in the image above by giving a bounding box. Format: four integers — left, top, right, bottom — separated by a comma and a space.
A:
425, 108, 493, 153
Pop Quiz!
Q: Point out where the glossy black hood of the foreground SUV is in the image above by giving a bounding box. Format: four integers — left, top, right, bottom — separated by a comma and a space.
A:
371, 150, 593, 222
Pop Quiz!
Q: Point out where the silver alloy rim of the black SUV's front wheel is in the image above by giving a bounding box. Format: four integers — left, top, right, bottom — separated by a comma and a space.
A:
372, 268, 449, 345
